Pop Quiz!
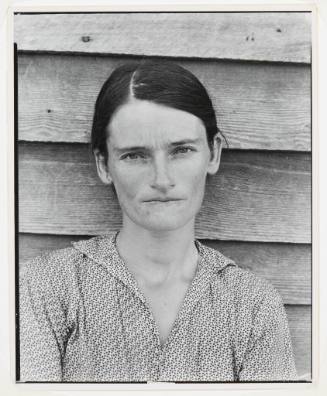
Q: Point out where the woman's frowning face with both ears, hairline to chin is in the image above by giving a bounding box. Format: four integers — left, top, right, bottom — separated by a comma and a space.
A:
97, 99, 220, 231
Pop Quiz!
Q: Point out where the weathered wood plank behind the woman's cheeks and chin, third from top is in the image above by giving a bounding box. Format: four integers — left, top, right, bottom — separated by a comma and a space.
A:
19, 143, 311, 243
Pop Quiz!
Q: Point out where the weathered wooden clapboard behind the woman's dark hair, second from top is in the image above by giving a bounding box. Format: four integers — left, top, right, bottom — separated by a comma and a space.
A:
18, 54, 311, 151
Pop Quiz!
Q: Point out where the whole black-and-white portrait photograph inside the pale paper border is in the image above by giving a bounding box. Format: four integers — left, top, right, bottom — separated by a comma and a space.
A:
13, 10, 314, 383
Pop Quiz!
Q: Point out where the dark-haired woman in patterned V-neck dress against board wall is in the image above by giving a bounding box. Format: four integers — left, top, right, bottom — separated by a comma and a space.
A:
20, 61, 296, 382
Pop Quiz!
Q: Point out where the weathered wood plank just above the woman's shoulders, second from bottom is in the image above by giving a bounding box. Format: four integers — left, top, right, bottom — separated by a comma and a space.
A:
19, 234, 311, 304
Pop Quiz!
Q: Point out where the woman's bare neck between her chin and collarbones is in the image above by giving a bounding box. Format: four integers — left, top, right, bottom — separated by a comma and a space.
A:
117, 220, 198, 284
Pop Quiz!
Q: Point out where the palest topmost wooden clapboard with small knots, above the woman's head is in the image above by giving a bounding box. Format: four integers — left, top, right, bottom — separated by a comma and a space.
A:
14, 12, 311, 63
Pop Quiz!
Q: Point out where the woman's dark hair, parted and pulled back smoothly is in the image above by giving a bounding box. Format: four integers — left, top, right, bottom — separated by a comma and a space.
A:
91, 60, 223, 158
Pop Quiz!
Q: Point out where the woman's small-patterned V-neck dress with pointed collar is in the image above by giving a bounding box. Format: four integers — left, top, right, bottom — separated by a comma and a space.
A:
19, 234, 297, 382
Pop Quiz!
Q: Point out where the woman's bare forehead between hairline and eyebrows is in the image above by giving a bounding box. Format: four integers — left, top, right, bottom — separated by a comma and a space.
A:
109, 99, 206, 147
